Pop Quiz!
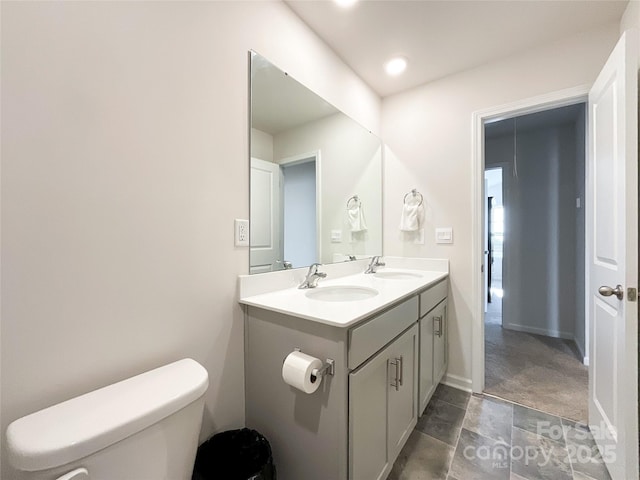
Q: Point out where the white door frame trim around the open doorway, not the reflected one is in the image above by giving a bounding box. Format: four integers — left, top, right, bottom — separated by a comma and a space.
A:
471, 85, 591, 393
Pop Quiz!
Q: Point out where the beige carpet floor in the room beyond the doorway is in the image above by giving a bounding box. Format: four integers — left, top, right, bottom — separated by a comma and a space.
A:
485, 299, 589, 423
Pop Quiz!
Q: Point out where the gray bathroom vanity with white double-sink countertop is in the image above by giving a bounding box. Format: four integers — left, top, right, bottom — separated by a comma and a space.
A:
240, 257, 448, 480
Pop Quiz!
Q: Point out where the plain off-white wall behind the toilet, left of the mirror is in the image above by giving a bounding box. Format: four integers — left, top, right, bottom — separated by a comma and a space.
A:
1, 1, 380, 479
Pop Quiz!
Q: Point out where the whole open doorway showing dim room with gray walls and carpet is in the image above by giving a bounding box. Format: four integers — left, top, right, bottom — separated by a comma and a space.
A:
484, 103, 588, 422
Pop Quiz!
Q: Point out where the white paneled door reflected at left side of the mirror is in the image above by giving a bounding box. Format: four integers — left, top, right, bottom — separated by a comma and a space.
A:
249, 158, 283, 273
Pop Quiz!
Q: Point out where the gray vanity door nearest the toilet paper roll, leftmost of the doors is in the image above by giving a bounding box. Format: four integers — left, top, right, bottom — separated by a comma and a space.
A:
349, 347, 393, 480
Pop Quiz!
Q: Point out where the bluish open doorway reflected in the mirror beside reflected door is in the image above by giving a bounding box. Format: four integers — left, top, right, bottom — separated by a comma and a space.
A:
281, 156, 319, 268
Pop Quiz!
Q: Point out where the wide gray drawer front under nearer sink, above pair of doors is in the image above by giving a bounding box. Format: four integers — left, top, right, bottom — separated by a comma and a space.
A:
349, 297, 418, 369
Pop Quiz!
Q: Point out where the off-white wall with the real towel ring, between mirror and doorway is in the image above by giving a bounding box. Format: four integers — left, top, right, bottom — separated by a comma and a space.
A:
382, 24, 619, 388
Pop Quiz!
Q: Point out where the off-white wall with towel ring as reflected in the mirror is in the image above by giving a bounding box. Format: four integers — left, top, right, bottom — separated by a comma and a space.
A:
273, 113, 382, 263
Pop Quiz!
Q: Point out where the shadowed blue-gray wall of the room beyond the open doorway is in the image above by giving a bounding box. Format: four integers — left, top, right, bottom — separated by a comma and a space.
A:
486, 110, 584, 344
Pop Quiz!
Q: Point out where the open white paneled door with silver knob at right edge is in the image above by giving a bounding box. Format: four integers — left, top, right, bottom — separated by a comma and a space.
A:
587, 31, 638, 480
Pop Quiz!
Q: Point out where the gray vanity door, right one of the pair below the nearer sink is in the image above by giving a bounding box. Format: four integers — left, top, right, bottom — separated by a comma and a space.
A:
387, 324, 418, 461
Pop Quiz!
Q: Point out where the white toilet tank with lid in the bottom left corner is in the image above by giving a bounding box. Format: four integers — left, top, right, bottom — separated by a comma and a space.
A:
7, 359, 209, 480
